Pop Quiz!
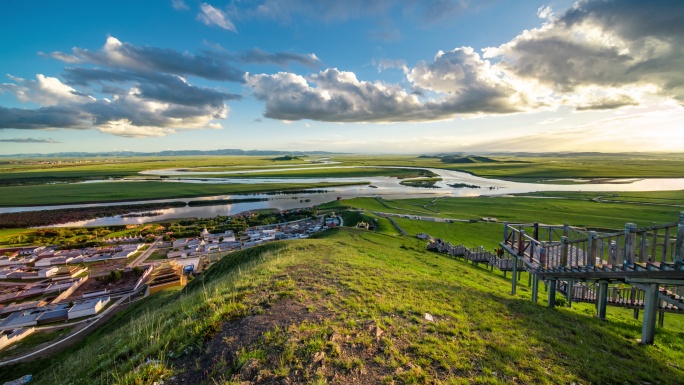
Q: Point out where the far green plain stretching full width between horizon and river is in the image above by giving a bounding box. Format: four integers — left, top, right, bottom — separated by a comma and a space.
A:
5, 154, 684, 180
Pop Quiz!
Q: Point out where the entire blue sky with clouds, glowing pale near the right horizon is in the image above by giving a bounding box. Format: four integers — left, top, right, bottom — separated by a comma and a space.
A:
0, 0, 684, 155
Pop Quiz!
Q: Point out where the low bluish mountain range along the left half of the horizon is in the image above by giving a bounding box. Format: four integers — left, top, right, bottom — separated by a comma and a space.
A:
0, 148, 339, 158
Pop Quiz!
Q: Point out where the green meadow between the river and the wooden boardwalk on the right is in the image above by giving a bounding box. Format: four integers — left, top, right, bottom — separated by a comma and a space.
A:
320, 193, 681, 229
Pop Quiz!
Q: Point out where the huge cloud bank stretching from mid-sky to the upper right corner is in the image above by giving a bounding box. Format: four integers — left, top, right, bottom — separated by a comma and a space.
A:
247, 0, 684, 122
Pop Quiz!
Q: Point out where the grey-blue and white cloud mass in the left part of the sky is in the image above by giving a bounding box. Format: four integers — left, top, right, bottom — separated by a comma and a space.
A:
0, 37, 250, 137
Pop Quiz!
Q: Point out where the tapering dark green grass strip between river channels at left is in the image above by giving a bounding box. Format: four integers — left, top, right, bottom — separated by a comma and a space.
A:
0, 182, 368, 206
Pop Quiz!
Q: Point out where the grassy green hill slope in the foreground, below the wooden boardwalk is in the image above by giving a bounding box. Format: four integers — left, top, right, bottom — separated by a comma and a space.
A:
0, 229, 684, 385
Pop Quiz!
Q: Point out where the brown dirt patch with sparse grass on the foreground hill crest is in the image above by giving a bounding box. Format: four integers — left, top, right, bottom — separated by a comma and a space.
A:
166, 267, 401, 385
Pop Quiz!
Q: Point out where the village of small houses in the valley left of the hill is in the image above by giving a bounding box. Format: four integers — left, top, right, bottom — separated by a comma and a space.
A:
0, 208, 343, 362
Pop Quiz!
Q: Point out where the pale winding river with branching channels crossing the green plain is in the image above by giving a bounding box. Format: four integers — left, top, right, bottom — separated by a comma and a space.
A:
0, 165, 684, 226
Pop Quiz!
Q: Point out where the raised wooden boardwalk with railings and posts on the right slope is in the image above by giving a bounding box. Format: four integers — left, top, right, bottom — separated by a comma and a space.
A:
500, 212, 684, 344
